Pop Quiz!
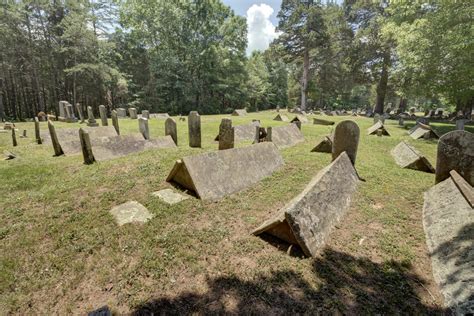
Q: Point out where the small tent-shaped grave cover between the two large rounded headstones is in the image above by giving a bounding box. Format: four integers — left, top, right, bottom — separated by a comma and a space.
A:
390, 141, 435, 173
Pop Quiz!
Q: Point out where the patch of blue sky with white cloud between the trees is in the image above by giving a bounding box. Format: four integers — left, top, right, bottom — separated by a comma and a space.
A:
222, 0, 281, 55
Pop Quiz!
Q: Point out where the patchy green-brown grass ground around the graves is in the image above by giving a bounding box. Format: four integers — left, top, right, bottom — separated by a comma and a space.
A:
0, 111, 474, 314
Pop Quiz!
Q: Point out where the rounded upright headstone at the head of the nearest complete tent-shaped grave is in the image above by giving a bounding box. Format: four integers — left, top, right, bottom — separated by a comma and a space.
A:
332, 120, 360, 165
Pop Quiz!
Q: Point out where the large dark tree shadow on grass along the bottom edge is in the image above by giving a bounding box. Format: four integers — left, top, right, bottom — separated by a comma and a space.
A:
133, 248, 444, 315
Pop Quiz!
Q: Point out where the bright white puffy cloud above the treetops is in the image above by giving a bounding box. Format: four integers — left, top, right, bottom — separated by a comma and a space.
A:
247, 3, 279, 54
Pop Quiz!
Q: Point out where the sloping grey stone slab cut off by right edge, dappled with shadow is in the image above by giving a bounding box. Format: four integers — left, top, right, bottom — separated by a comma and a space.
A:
423, 178, 474, 315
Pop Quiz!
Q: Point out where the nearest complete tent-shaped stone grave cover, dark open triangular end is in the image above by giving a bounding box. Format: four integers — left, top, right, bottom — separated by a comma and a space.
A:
253, 153, 359, 257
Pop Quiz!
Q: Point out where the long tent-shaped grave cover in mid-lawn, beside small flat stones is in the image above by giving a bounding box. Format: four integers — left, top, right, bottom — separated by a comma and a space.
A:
166, 142, 283, 200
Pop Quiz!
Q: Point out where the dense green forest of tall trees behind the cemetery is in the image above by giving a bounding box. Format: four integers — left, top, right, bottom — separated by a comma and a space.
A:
0, 0, 474, 121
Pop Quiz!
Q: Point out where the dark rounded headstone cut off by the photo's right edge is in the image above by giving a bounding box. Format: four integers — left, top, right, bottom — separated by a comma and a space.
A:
436, 131, 474, 186
